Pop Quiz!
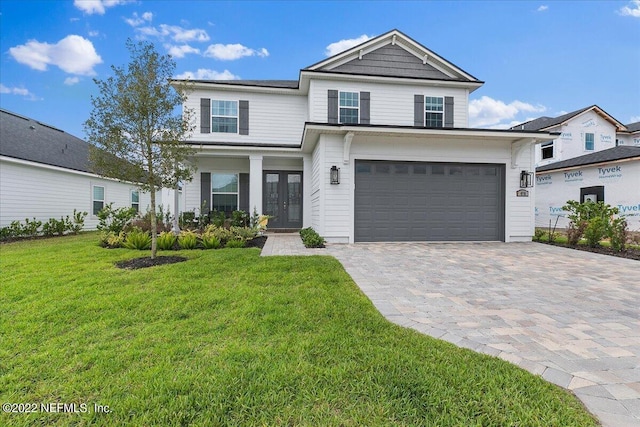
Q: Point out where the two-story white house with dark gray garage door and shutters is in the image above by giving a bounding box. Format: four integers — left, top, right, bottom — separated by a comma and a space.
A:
171, 30, 557, 243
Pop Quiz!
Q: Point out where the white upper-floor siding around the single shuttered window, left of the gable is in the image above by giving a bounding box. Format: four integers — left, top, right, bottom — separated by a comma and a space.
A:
185, 89, 307, 145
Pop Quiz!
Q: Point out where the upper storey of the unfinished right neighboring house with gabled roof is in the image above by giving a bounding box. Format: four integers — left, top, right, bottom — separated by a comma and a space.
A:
511, 105, 627, 166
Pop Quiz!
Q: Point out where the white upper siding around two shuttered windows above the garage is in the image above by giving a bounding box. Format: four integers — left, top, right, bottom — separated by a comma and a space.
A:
309, 80, 469, 128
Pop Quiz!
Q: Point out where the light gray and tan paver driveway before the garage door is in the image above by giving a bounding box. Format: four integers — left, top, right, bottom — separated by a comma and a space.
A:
328, 243, 640, 427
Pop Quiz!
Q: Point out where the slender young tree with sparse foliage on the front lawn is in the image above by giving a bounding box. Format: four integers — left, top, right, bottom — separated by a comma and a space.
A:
84, 39, 193, 258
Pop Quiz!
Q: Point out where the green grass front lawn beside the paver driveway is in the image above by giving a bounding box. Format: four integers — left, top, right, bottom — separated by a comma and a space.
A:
0, 234, 597, 427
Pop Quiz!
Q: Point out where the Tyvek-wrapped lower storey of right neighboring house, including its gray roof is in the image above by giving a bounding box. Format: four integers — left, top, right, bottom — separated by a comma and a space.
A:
536, 145, 640, 231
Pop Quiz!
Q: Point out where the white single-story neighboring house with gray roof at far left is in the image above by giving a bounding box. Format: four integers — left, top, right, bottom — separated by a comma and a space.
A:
0, 110, 173, 229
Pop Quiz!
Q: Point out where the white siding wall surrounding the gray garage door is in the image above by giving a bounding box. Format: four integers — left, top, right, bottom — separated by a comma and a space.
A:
313, 135, 534, 243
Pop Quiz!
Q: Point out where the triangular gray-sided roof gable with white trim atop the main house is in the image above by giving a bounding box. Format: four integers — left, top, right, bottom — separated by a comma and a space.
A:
304, 30, 482, 83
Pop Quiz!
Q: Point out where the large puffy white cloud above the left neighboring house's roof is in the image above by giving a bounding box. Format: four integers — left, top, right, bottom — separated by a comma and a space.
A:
9, 35, 102, 76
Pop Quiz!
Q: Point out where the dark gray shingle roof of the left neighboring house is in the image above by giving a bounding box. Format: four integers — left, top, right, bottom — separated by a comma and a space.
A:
0, 109, 92, 173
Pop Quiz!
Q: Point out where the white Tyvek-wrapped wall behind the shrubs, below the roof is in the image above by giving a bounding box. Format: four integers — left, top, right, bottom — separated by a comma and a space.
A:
535, 160, 640, 231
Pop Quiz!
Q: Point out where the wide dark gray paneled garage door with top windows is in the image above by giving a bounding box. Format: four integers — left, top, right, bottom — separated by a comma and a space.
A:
355, 160, 505, 242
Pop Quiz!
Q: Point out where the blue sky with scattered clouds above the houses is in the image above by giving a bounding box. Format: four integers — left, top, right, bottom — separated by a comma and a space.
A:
0, 0, 640, 138
